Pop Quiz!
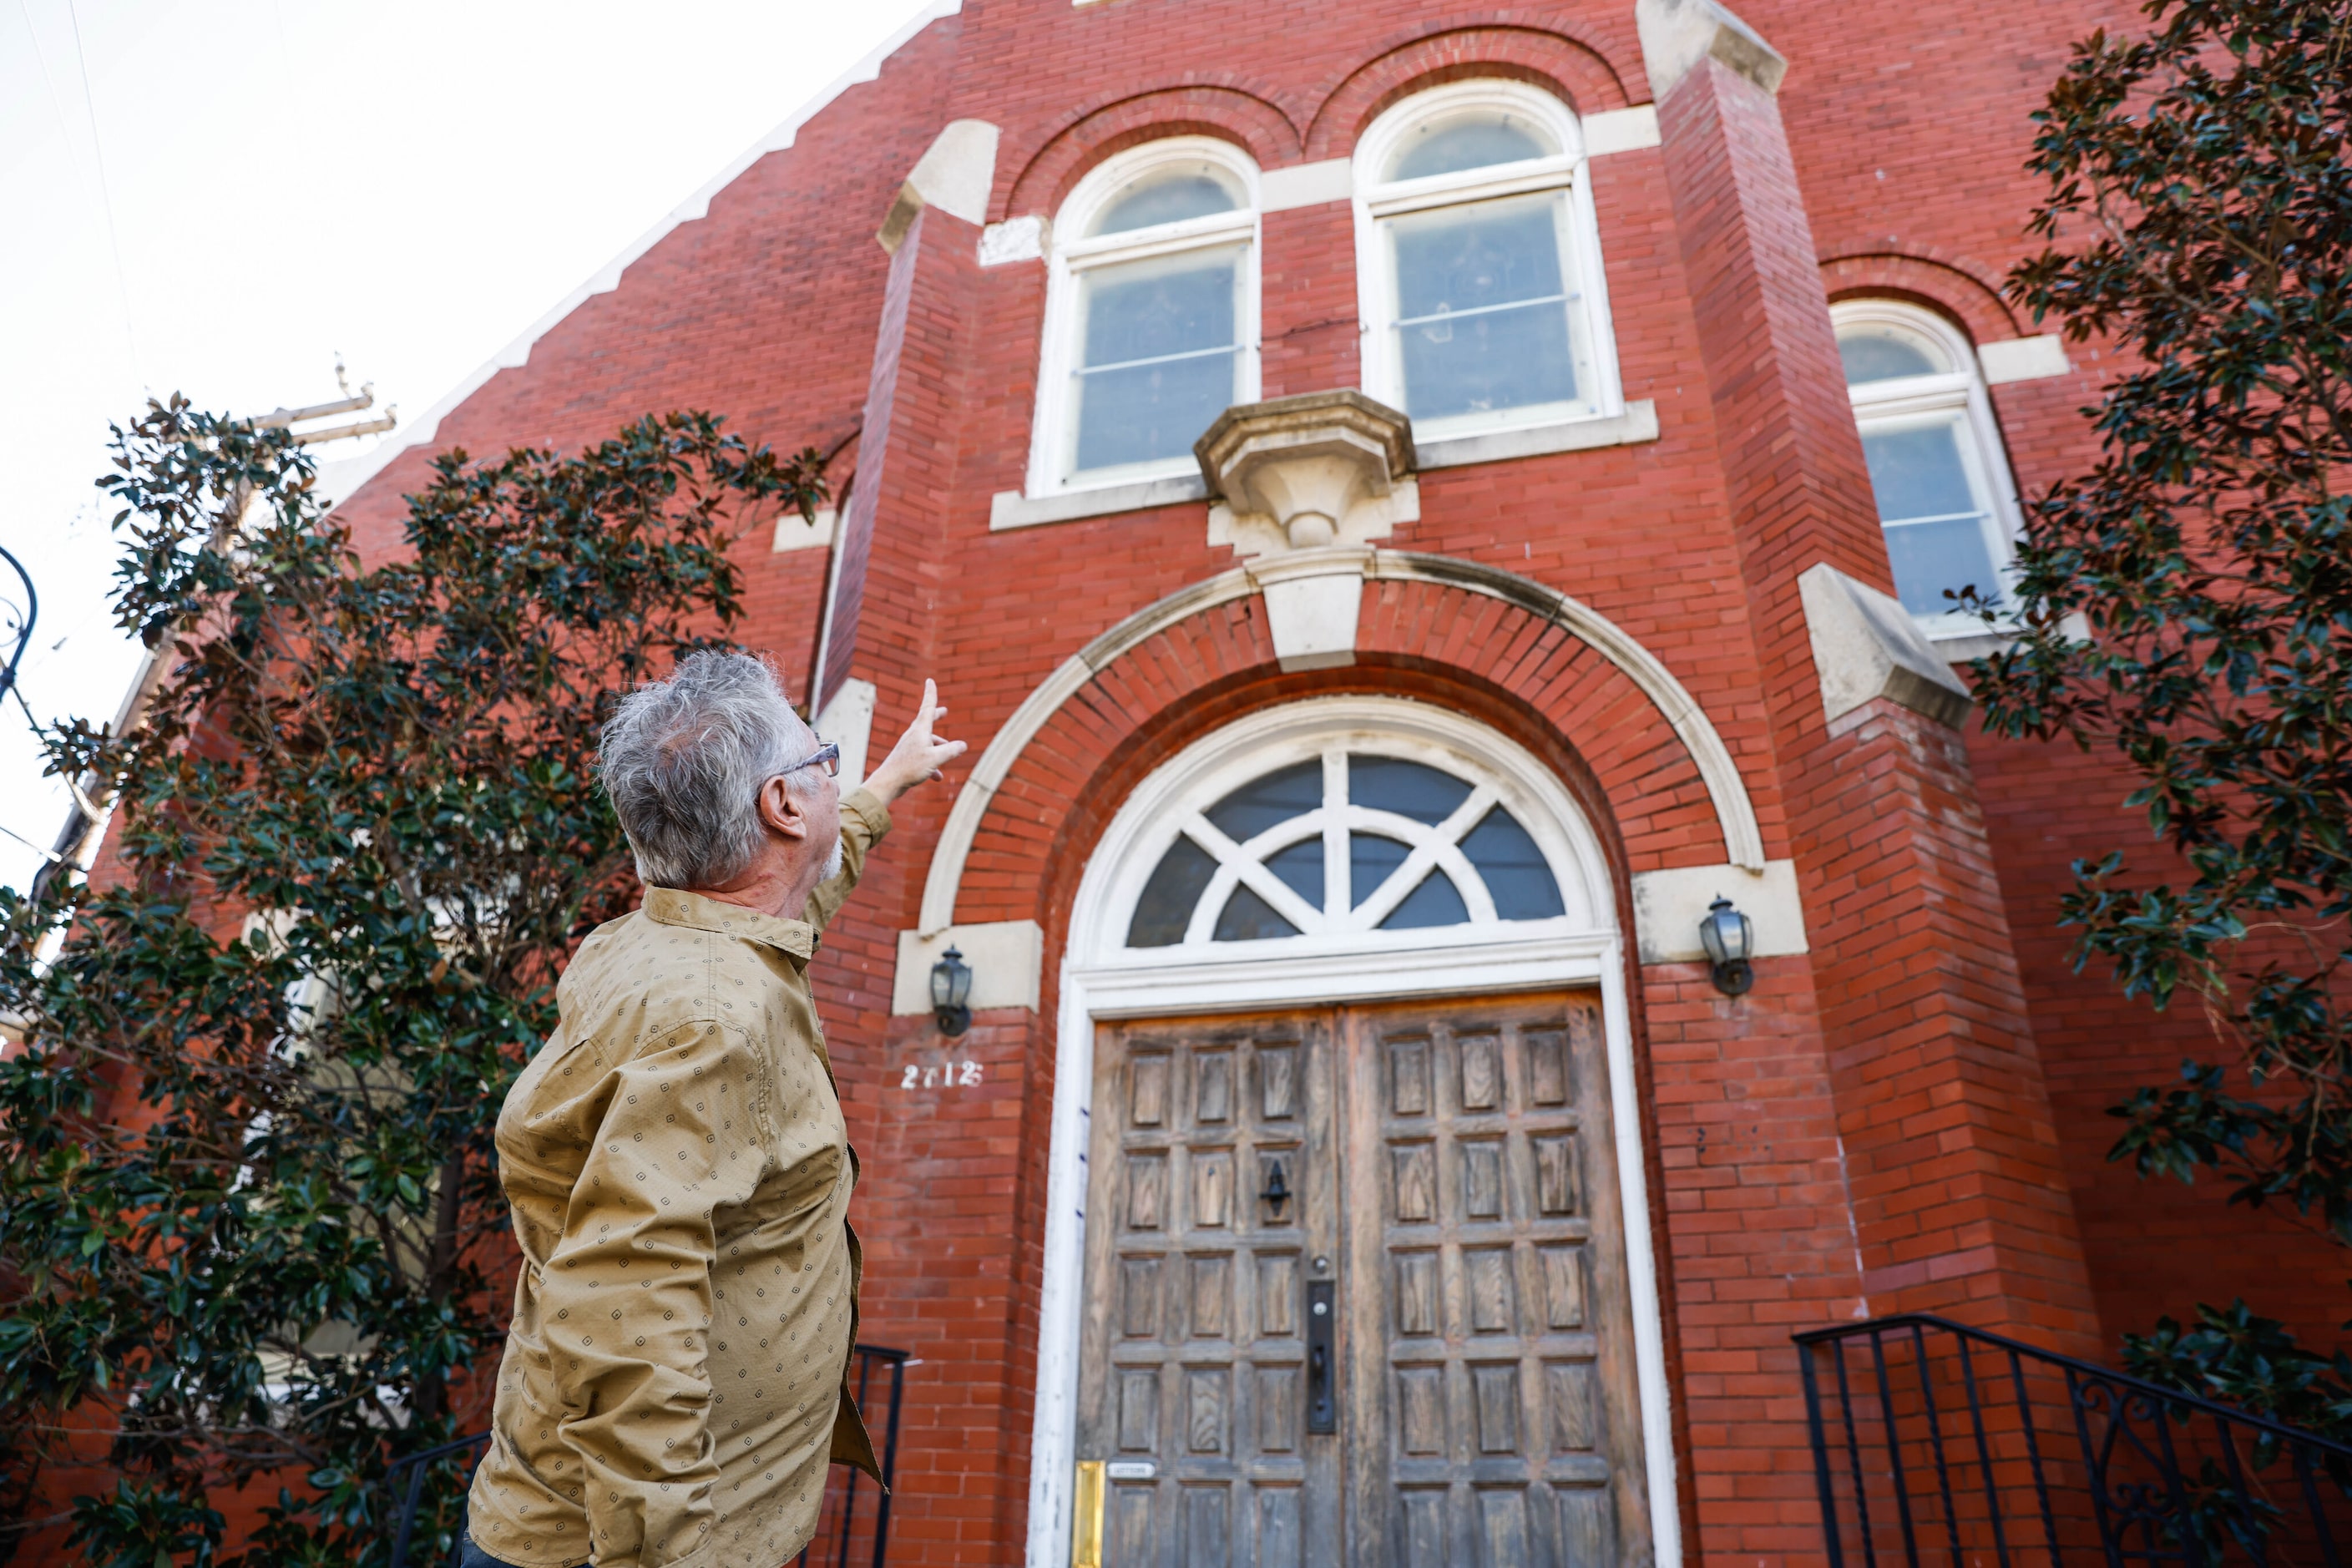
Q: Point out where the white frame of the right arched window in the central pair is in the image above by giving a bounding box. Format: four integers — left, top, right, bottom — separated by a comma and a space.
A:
1355, 78, 1626, 440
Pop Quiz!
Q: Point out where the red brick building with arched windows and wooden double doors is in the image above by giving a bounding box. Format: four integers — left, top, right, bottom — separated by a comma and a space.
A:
303, 0, 2338, 1565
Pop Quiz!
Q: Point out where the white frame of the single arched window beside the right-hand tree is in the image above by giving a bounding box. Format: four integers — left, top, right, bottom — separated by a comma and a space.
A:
1830, 299, 2025, 640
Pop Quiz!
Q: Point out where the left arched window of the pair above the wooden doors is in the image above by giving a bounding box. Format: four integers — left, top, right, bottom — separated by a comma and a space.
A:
1030, 136, 1258, 496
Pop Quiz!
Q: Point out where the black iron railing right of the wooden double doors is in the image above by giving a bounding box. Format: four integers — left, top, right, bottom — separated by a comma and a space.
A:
1794, 1314, 2352, 1568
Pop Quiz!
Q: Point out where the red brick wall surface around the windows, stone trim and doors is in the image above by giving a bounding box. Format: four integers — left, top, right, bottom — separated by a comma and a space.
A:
41, 0, 2340, 1563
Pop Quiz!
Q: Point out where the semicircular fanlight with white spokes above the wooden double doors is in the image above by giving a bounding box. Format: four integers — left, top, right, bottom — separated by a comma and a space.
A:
1125, 726, 1590, 954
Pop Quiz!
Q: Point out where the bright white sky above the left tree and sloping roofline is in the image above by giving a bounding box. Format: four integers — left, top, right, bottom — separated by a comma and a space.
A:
0, 0, 924, 886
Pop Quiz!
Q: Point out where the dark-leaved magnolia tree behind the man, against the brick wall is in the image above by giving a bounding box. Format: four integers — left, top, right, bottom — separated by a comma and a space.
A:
0, 397, 823, 1568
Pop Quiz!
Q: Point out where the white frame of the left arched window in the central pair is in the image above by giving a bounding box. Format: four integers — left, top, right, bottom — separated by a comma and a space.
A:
1028, 136, 1258, 498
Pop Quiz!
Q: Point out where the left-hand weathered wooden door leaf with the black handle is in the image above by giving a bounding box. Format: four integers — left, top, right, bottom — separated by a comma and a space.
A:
1077, 1011, 1341, 1568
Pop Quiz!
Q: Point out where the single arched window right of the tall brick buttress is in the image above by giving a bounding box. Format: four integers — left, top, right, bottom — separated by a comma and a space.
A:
1830, 299, 2018, 637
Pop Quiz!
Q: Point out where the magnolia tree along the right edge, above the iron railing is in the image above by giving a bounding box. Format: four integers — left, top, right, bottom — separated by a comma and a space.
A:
1975, 0, 2352, 1427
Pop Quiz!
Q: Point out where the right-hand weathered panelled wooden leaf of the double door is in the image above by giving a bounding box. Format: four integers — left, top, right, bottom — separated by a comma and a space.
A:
1341, 994, 1649, 1568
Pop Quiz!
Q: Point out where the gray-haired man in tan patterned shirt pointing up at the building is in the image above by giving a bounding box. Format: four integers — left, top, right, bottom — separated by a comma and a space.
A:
463, 651, 964, 1568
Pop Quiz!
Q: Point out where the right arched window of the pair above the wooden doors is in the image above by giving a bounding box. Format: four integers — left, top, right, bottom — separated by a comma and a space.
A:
1355, 80, 1621, 440
